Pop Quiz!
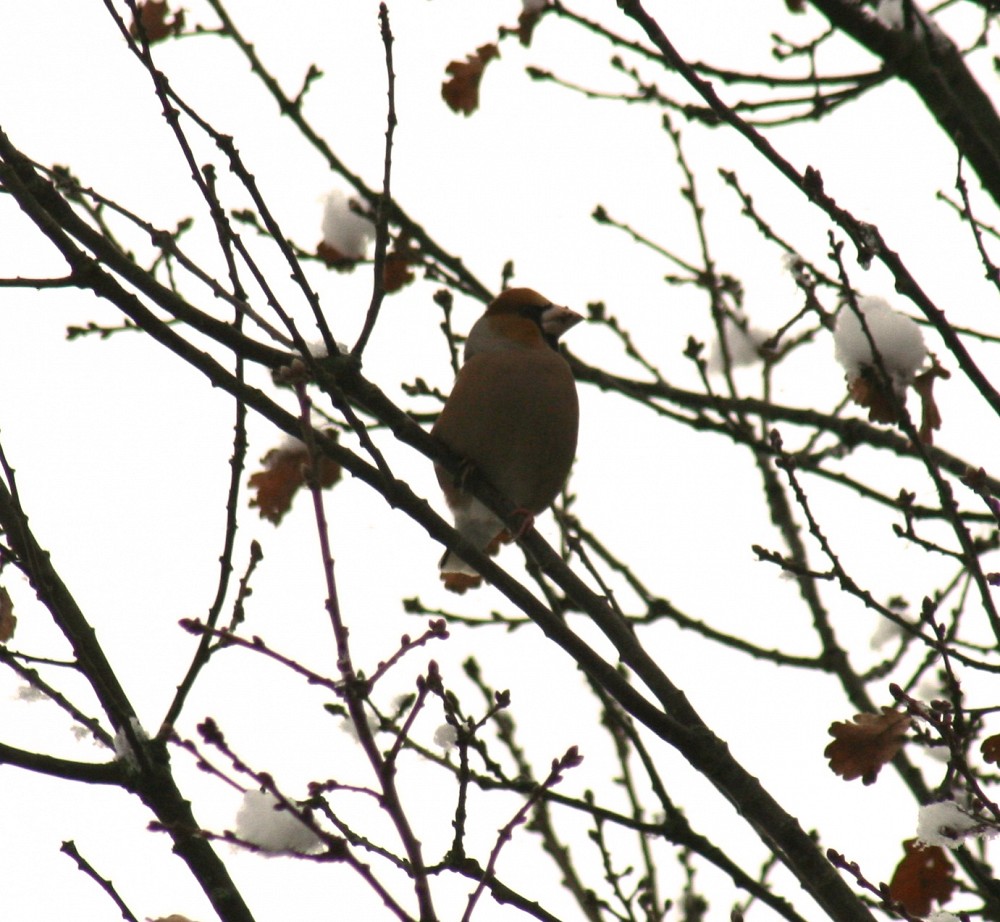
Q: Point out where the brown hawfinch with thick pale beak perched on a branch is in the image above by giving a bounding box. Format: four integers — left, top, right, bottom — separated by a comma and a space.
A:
431, 288, 583, 593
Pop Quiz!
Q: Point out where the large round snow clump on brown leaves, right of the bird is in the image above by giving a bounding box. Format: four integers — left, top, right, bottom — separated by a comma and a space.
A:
833, 297, 927, 394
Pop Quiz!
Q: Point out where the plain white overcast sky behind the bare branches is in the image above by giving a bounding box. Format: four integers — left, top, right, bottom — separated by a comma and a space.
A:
0, 0, 1000, 922
